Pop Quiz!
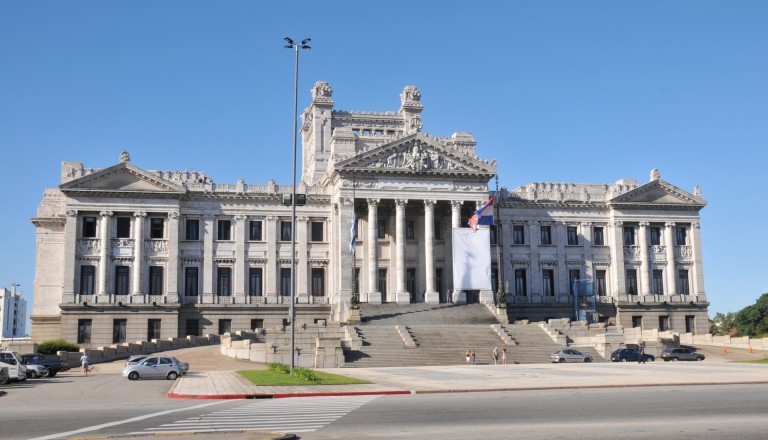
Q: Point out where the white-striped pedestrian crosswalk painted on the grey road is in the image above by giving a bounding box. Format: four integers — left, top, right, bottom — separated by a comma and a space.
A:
131, 396, 379, 435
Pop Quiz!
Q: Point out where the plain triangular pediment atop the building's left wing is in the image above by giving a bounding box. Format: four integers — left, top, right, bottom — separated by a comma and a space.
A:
59, 162, 186, 194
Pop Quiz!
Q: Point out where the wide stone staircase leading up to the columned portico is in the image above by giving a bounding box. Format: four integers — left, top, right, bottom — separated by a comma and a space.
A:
344, 304, 603, 367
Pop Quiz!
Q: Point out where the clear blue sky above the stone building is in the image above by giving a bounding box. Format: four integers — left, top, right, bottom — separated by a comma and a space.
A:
0, 0, 768, 324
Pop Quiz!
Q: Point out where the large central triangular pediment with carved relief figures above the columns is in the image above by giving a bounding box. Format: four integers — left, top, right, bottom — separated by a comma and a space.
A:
334, 133, 496, 176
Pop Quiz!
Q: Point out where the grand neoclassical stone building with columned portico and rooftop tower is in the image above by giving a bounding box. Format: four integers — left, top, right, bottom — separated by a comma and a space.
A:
31, 82, 708, 347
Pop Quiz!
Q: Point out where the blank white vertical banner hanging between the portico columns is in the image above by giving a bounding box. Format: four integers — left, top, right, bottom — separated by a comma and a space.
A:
453, 228, 491, 290
